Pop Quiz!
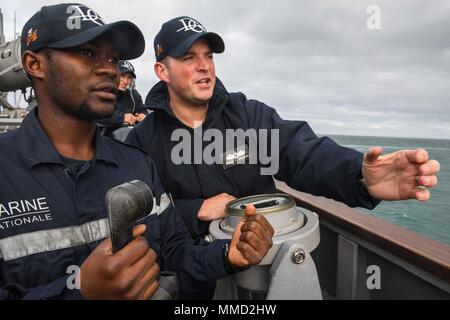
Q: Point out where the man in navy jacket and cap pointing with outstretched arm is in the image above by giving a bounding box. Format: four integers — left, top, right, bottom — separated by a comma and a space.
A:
128, 17, 439, 237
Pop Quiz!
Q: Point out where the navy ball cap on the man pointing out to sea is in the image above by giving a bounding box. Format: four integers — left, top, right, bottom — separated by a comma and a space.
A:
153, 16, 225, 61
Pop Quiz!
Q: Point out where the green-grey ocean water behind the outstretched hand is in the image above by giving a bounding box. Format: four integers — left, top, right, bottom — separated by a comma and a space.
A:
329, 135, 450, 244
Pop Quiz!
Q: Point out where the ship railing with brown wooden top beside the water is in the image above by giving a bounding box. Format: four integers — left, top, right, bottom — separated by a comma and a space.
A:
276, 181, 450, 300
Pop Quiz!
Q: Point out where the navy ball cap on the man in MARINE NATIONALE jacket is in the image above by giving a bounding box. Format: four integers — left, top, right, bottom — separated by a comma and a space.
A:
21, 3, 145, 59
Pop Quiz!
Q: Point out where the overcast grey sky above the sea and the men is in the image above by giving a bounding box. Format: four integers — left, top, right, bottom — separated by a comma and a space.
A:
0, 0, 450, 139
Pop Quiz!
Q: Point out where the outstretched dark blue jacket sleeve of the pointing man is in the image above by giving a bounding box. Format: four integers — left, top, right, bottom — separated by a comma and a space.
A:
246, 100, 380, 209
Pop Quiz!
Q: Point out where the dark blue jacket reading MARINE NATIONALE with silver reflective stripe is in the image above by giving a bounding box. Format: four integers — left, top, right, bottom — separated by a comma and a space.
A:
0, 108, 226, 299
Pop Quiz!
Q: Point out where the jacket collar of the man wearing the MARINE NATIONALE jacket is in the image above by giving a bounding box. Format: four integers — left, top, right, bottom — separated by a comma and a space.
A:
19, 107, 118, 168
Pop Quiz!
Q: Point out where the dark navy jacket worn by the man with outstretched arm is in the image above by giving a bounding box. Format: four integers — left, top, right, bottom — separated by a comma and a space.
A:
127, 80, 378, 236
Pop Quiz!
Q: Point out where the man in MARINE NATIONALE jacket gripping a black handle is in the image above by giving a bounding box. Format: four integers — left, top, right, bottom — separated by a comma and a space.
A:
0, 4, 273, 299
